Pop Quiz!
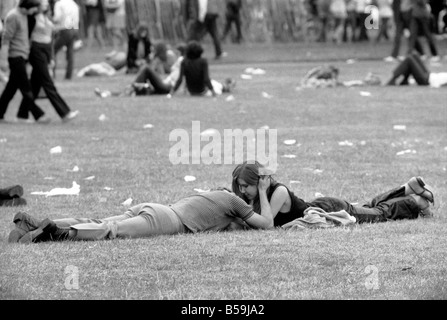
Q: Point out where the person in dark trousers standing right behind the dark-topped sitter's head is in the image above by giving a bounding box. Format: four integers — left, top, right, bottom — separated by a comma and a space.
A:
185, 0, 226, 60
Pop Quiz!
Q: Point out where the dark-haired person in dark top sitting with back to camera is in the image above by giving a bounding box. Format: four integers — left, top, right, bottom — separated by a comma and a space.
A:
170, 40, 236, 97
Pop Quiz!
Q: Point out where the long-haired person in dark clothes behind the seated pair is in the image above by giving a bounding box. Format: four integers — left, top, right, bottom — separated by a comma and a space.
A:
126, 22, 152, 74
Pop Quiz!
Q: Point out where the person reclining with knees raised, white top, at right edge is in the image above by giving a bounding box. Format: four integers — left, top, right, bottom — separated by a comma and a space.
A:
386, 52, 447, 88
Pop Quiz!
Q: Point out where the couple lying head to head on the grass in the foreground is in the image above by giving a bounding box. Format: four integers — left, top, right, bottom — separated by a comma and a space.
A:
9, 162, 434, 243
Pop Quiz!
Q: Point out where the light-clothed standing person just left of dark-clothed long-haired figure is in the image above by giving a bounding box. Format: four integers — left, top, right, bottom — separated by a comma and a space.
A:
104, 0, 126, 50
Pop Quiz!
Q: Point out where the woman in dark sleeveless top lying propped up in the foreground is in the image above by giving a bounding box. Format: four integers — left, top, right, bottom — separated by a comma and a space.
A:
232, 162, 434, 226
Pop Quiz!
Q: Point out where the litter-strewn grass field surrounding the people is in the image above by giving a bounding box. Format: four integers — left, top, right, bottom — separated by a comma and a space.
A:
0, 38, 447, 300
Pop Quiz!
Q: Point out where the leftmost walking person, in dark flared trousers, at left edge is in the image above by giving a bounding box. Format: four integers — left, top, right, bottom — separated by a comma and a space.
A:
0, 0, 50, 123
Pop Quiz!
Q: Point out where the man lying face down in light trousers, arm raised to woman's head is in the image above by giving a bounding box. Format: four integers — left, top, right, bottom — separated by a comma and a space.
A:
9, 178, 273, 243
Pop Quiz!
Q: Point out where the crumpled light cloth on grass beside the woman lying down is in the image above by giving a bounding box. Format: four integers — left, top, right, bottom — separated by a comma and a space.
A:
281, 207, 357, 230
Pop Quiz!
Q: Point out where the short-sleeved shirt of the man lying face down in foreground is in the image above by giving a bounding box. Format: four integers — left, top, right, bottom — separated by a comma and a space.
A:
171, 191, 254, 232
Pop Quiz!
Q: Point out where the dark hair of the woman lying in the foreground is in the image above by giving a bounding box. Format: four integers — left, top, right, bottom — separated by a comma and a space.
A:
231, 161, 277, 213
